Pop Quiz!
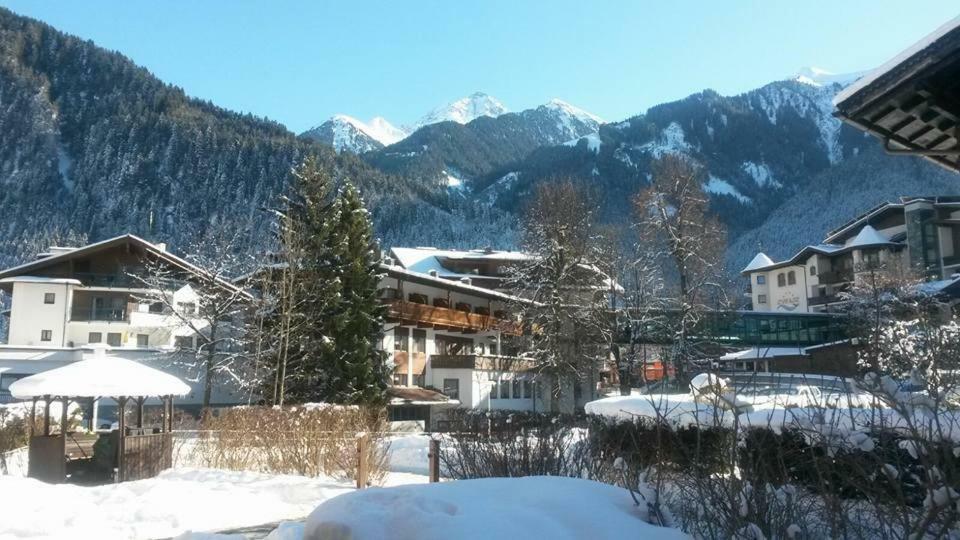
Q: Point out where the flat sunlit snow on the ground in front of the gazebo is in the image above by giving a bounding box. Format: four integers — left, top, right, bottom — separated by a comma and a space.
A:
0, 469, 426, 538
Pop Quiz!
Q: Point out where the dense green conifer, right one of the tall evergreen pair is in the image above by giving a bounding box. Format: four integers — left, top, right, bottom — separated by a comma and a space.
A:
330, 182, 385, 404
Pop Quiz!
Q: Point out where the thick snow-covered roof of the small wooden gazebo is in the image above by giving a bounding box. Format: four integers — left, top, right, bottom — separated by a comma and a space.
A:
10, 355, 190, 399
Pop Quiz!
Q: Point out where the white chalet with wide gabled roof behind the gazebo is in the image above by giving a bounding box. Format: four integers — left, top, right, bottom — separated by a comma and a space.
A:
0, 234, 245, 405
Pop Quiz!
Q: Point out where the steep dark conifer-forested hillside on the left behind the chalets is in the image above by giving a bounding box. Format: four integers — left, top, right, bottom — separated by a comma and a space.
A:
0, 9, 484, 264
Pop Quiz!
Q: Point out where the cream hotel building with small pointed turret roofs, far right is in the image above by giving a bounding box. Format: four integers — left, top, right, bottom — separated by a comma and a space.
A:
741, 196, 960, 313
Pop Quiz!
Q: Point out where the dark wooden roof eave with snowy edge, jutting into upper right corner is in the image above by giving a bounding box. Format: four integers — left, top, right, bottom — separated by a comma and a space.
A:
834, 17, 960, 171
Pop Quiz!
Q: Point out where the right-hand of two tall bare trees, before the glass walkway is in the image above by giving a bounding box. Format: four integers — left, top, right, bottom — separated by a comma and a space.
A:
634, 154, 727, 384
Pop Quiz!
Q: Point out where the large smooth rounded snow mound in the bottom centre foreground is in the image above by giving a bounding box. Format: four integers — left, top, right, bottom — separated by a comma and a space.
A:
304, 476, 688, 540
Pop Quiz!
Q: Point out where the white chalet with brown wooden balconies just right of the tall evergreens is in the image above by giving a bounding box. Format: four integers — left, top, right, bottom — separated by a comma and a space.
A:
380, 260, 598, 429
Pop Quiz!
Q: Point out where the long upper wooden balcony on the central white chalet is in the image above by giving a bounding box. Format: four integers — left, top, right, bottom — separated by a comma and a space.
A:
384, 300, 522, 336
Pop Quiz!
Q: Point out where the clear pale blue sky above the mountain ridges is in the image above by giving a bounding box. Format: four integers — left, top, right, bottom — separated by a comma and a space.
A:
0, 0, 960, 132
